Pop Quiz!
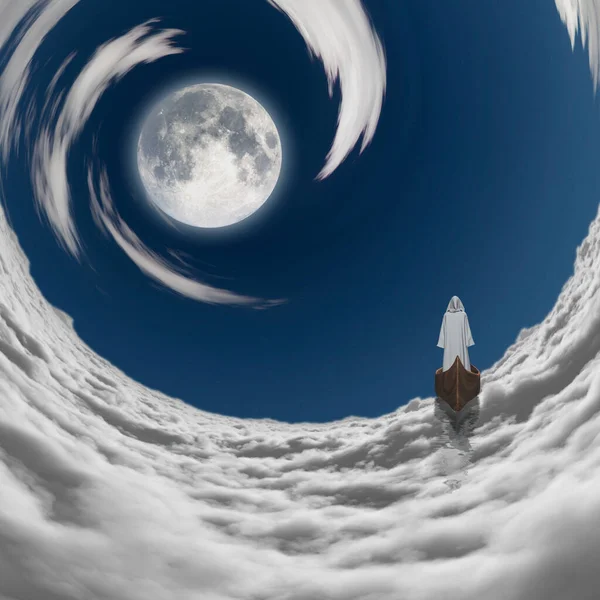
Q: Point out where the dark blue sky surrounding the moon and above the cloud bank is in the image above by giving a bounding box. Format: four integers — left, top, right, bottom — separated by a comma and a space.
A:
7, 0, 600, 421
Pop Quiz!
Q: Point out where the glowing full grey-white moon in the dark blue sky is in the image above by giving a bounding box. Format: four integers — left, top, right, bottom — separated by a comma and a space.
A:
137, 83, 282, 228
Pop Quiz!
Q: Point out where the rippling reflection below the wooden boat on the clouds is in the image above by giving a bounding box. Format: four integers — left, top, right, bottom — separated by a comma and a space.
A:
434, 397, 480, 490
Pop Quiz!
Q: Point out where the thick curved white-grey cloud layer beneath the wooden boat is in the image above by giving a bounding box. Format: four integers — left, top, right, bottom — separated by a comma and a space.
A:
0, 2, 600, 600
